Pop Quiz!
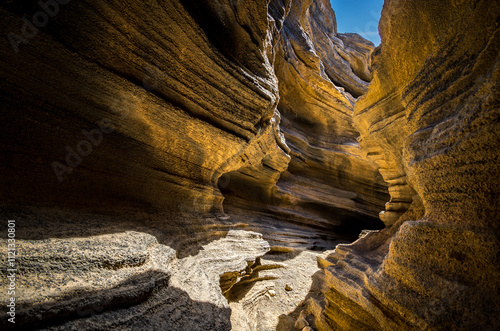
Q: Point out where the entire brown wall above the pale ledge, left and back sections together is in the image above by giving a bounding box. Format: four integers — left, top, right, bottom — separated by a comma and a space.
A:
0, 0, 387, 253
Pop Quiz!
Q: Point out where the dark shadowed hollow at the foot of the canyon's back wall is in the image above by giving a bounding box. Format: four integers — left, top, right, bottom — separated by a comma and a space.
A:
224, 193, 383, 251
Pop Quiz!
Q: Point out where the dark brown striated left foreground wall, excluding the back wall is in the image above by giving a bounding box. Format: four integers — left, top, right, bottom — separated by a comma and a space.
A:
0, 0, 286, 252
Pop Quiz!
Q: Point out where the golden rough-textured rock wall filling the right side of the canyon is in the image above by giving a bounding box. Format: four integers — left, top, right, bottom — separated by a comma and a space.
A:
296, 0, 500, 330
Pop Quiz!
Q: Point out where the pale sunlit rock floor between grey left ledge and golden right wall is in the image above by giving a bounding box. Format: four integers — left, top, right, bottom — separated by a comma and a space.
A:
229, 247, 331, 331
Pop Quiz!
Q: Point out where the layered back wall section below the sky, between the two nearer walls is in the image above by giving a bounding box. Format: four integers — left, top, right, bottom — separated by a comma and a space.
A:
220, 0, 388, 249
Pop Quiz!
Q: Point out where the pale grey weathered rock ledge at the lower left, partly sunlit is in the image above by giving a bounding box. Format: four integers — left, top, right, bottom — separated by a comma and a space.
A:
0, 231, 269, 330
